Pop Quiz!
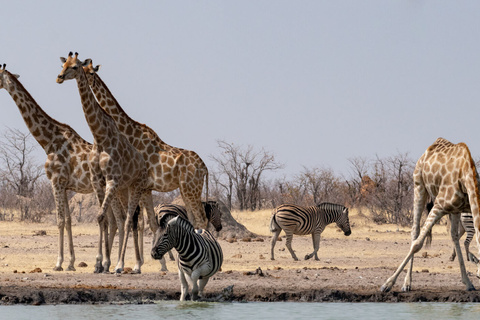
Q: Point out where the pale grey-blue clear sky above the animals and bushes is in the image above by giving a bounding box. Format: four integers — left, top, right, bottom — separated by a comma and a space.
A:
0, 0, 480, 177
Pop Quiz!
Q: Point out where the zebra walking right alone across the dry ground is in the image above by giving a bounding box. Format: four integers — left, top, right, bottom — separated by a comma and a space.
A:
270, 202, 352, 261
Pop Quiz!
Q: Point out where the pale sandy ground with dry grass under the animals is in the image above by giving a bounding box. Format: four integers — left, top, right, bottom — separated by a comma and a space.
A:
0, 213, 480, 304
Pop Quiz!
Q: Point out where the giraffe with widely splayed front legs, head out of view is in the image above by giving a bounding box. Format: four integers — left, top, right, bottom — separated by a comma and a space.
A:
381, 138, 480, 292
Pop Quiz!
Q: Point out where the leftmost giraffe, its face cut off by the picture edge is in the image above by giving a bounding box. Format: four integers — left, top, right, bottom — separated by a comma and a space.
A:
0, 64, 123, 271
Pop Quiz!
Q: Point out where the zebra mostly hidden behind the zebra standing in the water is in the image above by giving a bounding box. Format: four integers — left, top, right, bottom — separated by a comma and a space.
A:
155, 200, 223, 271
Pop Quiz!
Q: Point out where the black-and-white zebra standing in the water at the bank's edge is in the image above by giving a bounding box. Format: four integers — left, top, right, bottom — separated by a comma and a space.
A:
152, 213, 223, 301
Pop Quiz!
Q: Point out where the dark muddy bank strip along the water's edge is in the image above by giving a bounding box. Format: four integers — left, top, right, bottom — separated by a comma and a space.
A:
0, 287, 480, 305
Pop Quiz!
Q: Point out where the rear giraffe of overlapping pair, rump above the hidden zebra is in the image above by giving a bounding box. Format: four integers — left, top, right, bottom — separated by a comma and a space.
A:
85, 63, 208, 232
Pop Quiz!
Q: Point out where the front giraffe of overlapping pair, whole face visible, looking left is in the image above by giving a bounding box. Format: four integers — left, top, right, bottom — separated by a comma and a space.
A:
57, 52, 148, 273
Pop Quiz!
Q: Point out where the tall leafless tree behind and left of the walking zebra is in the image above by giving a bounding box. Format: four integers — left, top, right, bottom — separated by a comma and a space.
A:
211, 140, 283, 210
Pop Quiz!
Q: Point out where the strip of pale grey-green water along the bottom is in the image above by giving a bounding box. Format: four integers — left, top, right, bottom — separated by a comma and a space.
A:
0, 301, 480, 320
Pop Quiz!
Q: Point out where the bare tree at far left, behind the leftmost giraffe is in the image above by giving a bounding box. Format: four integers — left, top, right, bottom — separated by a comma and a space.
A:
0, 129, 44, 220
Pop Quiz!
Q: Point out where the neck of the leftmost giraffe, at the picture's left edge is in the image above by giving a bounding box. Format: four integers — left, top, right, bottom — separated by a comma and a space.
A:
4, 70, 73, 154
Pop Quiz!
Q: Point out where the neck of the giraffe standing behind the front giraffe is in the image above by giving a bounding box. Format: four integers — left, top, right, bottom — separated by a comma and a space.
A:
89, 73, 170, 151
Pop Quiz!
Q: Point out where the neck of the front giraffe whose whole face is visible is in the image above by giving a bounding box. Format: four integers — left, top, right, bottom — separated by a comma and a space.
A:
76, 69, 118, 145
